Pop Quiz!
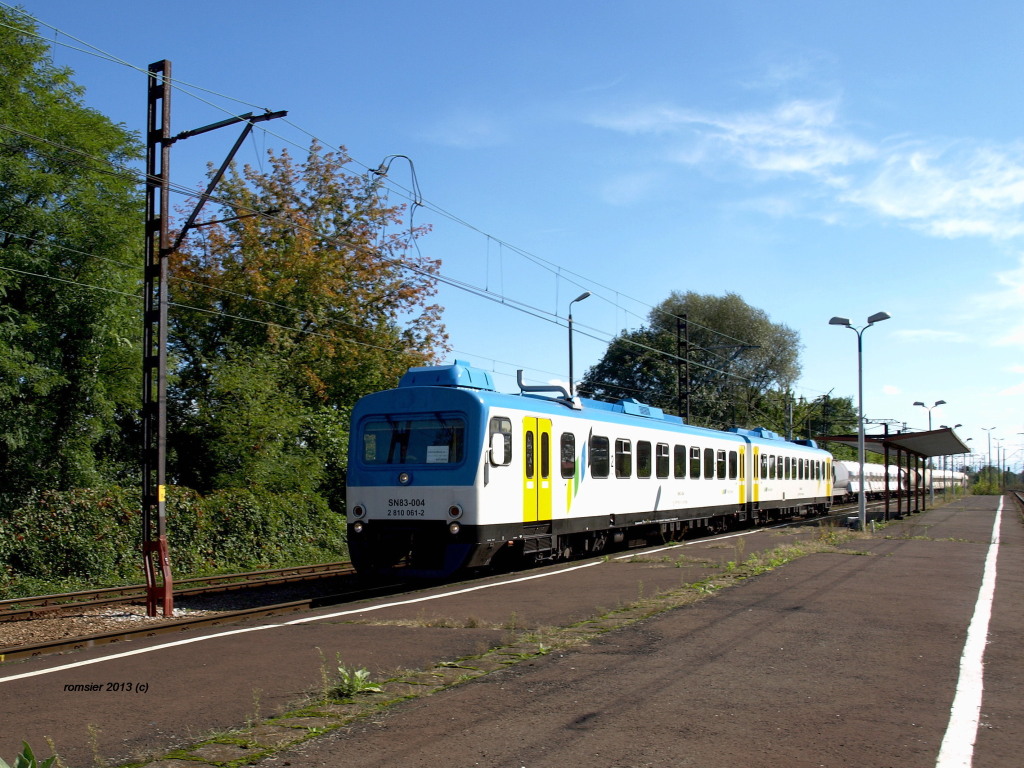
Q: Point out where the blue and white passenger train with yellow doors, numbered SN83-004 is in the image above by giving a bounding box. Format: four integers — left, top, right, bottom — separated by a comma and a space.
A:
347, 360, 833, 577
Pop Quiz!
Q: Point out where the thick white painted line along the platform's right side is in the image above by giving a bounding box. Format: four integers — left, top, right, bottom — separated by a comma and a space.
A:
935, 499, 1002, 768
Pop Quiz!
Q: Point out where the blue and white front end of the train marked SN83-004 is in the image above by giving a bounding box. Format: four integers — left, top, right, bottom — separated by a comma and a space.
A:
347, 361, 494, 578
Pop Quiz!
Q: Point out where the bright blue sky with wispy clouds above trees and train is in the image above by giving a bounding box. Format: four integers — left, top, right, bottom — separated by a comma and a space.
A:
8, 0, 1024, 466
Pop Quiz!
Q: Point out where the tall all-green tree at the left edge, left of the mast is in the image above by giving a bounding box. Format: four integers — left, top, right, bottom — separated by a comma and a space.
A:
0, 8, 142, 509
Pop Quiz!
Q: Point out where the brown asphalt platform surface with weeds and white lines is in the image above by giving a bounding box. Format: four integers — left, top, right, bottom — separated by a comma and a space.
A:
0, 497, 1024, 768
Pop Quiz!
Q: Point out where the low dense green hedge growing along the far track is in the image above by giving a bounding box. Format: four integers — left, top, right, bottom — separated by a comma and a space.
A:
0, 486, 347, 597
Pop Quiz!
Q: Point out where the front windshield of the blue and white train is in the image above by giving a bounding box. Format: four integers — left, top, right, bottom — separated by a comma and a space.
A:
362, 415, 466, 465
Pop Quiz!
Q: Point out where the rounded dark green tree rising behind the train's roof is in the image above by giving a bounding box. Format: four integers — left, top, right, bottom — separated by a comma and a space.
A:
581, 292, 800, 429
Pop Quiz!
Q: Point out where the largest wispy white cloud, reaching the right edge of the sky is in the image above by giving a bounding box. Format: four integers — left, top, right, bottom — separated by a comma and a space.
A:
590, 92, 1024, 241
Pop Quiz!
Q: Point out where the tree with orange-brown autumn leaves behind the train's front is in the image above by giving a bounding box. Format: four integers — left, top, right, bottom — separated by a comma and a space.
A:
171, 144, 446, 490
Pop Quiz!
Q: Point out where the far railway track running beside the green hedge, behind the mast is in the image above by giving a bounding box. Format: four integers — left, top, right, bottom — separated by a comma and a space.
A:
0, 562, 355, 623
